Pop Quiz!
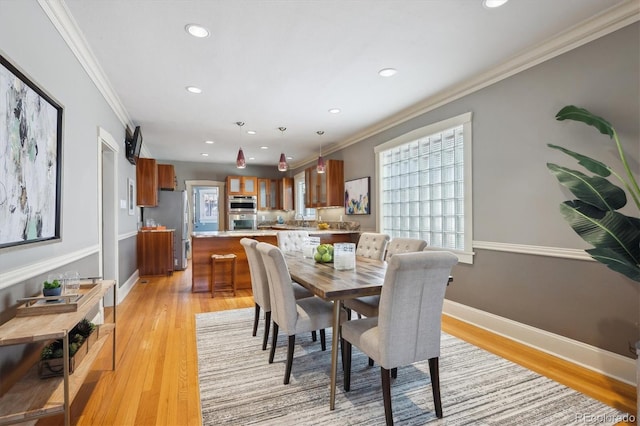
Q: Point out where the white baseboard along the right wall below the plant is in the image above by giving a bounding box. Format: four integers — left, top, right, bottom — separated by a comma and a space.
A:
443, 300, 636, 386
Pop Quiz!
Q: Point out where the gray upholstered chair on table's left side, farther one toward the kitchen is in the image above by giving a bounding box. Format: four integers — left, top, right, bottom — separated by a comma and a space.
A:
240, 238, 313, 351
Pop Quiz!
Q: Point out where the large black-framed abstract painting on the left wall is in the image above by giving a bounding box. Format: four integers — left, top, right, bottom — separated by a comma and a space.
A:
0, 56, 62, 249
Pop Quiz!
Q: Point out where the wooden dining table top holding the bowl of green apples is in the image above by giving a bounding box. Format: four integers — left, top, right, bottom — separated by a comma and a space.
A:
285, 252, 387, 300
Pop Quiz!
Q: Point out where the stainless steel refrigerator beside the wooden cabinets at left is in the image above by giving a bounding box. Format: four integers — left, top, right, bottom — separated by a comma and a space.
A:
149, 191, 189, 270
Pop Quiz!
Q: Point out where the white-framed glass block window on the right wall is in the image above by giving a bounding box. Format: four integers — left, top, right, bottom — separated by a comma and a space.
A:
375, 113, 472, 263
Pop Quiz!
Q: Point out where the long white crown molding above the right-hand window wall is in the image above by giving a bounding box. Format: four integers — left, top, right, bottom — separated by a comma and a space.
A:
292, 0, 640, 168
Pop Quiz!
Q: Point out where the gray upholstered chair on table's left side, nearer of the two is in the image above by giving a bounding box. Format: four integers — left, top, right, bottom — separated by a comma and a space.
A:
257, 242, 337, 385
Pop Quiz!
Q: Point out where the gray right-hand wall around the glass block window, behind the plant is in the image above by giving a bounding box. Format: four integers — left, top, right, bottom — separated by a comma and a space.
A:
297, 23, 640, 357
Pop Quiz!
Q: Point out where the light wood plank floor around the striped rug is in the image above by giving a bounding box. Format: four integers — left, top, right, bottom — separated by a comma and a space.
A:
38, 269, 636, 426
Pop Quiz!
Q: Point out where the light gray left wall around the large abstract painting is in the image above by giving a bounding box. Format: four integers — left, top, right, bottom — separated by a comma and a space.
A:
0, 1, 137, 382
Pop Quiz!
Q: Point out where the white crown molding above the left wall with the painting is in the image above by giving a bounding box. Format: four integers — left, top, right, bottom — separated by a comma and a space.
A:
38, 0, 135, 129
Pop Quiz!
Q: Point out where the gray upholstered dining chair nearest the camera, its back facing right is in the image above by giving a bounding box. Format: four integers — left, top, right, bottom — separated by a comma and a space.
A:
342, 251, 458, 425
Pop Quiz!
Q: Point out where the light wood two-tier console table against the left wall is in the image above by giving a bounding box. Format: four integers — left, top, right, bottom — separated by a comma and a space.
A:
0, 280, 116, 426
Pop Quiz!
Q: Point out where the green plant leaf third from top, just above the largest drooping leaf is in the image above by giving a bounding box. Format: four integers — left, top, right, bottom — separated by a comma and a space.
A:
547, 163, 627, 210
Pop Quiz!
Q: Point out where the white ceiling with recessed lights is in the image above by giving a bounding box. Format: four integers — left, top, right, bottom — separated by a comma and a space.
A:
60, 0, 628, 167
